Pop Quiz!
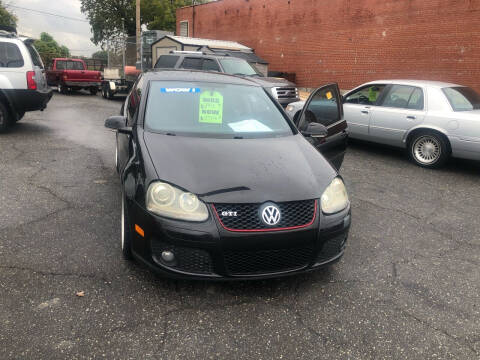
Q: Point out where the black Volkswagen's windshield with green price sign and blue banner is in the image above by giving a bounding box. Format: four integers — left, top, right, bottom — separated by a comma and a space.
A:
145, 81, 293, 138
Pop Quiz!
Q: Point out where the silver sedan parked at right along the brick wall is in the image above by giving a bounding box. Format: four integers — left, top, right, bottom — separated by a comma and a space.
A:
287, 80, 480, 168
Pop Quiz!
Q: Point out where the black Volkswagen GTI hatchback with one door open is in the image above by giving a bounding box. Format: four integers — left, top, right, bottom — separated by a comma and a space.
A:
105, 70, 350, 279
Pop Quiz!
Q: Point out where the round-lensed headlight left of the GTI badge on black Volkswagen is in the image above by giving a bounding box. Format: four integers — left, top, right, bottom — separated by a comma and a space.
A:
146, 182, 208, 221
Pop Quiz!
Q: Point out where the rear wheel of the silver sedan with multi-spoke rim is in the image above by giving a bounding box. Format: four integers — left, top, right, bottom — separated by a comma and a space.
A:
408, 130, 450, 169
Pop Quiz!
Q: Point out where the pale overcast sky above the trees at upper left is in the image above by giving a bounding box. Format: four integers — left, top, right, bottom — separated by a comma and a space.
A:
2, 0, 100, 56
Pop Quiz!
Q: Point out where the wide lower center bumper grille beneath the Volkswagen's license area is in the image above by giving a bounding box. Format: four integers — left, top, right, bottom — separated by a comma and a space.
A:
225, 246, 314, 275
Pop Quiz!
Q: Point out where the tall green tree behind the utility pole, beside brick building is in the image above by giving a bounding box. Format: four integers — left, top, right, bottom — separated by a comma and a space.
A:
80, 0, 210, 45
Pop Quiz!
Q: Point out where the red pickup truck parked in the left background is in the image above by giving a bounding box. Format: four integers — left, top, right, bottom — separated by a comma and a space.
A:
47, 58, 102, 95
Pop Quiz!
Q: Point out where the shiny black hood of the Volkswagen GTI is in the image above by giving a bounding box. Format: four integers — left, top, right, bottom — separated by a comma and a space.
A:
144, 132, 337, 203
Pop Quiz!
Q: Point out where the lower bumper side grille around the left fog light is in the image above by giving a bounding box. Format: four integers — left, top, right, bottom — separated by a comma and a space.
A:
152, 241, 213, 274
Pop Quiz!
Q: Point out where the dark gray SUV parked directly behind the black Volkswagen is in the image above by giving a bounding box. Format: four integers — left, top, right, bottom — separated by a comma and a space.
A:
155, 51, 300, 107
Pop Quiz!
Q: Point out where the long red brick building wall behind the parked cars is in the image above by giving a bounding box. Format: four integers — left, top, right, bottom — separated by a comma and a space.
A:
177, 0, 480, 91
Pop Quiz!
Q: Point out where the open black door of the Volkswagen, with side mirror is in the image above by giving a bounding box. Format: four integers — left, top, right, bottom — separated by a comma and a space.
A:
296, 84, 348, 170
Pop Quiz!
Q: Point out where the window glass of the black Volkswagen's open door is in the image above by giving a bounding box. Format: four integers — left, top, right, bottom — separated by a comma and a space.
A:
300, 87, 341, 128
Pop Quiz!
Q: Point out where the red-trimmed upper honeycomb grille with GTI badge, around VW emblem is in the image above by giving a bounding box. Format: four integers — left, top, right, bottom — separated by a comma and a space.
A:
214, 200, 316, 231
